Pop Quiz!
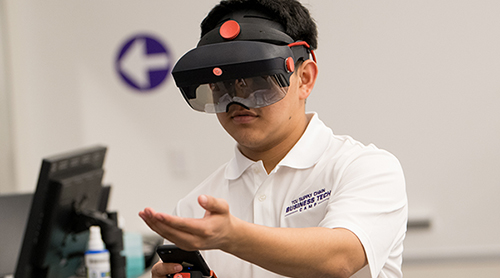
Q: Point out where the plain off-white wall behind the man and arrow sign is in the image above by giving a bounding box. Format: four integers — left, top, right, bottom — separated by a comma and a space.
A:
0, 0, 500, 270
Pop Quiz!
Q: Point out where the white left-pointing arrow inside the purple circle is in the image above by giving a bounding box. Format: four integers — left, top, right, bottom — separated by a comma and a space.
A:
120, 38, 169, 88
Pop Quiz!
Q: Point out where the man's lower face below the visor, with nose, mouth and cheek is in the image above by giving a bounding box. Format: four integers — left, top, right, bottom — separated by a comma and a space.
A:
217, 70, 304, 152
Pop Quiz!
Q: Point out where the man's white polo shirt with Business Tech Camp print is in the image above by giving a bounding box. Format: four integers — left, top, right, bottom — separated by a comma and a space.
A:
174, 114, 407, 278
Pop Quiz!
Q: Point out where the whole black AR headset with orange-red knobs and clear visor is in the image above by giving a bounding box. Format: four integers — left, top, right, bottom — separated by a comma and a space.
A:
172, 10, 316, 113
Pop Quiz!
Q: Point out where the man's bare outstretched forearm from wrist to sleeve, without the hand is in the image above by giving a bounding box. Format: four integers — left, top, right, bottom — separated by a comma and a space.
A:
222, 219, 367, 278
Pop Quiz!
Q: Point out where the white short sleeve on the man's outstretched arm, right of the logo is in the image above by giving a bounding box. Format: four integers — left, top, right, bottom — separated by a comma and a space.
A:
320, 147, 408, 278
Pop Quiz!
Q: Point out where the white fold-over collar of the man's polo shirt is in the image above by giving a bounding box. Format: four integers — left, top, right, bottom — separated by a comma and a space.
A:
225, 112, 332, 180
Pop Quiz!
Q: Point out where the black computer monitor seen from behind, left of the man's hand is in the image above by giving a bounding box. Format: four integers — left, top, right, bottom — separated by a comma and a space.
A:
14, 146, 116, 278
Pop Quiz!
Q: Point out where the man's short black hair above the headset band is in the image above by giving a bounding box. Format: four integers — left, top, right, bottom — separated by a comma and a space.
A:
201, 0, 318, 50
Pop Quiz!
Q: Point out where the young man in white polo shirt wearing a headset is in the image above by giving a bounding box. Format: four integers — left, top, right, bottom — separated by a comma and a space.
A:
140, 0, 407, 278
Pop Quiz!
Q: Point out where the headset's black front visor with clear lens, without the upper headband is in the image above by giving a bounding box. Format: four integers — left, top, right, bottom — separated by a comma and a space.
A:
172, 41, 309, 113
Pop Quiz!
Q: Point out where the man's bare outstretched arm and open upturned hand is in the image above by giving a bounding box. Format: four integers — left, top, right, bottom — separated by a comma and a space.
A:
140, 195, 367, 278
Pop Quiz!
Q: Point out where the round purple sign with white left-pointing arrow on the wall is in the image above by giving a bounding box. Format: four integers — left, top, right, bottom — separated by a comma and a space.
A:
116, 35, 171, 91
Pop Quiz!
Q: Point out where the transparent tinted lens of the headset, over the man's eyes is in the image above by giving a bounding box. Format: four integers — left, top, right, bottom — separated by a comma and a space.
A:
188, 75, 288, 113
